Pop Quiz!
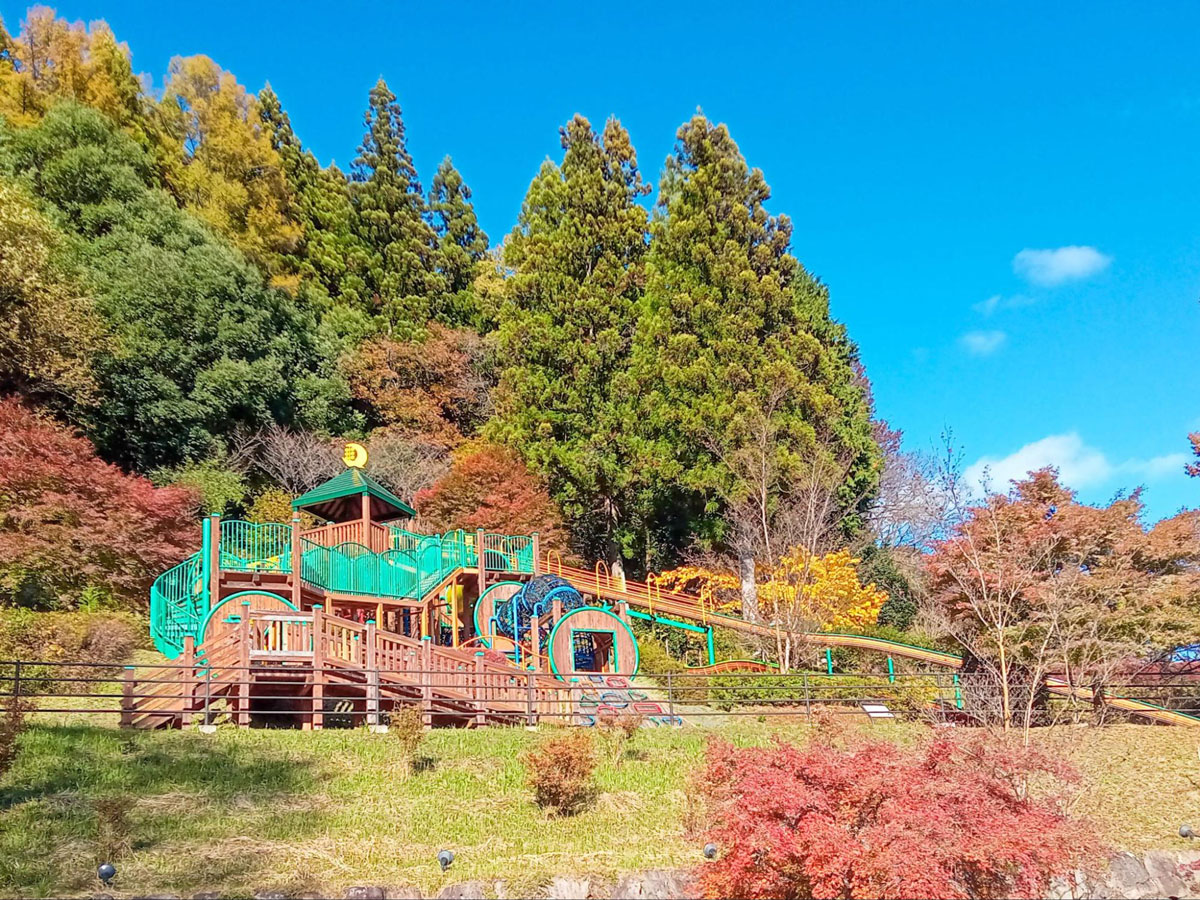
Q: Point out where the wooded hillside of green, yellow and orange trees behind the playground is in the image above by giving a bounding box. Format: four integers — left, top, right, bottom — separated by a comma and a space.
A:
0, 7, 882, 606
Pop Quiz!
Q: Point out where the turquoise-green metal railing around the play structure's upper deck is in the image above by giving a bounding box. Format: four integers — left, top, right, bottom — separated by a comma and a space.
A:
150, 520, 534, 659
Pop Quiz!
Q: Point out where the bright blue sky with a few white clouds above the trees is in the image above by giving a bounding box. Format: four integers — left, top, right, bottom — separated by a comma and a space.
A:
9, 0, 1200, 518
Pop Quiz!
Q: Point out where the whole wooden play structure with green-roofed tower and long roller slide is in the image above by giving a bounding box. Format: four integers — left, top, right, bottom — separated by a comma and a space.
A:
129, 457, 1200, 728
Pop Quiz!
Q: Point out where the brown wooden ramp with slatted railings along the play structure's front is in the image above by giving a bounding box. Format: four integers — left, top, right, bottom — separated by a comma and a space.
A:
121, 607, 574, 728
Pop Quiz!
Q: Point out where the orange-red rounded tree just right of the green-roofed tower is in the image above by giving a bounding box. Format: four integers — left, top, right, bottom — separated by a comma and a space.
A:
413, 444, 566, 552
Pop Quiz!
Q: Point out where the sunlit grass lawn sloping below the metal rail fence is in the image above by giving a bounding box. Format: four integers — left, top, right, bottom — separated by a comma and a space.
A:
0, 719, 1200, 896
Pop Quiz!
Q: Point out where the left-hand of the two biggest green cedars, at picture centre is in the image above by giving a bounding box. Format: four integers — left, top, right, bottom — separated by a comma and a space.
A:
496, 116, 649, 571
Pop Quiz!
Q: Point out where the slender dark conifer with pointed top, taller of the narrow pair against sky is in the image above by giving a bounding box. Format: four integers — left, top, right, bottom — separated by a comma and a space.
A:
350, 78, 444, 336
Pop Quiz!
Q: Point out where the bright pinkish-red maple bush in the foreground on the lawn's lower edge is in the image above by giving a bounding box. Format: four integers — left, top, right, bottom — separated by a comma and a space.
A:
697, 736, 1100, 898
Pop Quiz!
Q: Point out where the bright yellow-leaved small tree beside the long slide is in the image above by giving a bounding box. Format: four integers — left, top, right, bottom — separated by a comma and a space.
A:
758, 547, 888, 631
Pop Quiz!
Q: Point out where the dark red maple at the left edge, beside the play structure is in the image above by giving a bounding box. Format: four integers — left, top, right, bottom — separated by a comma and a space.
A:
0, 400, 197, 608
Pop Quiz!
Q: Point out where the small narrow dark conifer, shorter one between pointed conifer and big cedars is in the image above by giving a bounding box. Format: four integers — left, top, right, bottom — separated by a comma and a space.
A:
430, 156, 487, 325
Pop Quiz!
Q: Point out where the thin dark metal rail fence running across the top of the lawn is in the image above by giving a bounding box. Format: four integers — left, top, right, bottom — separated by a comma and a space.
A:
0, 660, 1200, 727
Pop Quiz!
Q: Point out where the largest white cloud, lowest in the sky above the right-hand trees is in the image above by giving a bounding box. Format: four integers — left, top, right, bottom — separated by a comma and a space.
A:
964, 432, 1188, 491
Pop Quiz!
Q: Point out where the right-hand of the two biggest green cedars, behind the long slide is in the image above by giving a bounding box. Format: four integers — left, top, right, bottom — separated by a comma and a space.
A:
634, 114, 880, 561
